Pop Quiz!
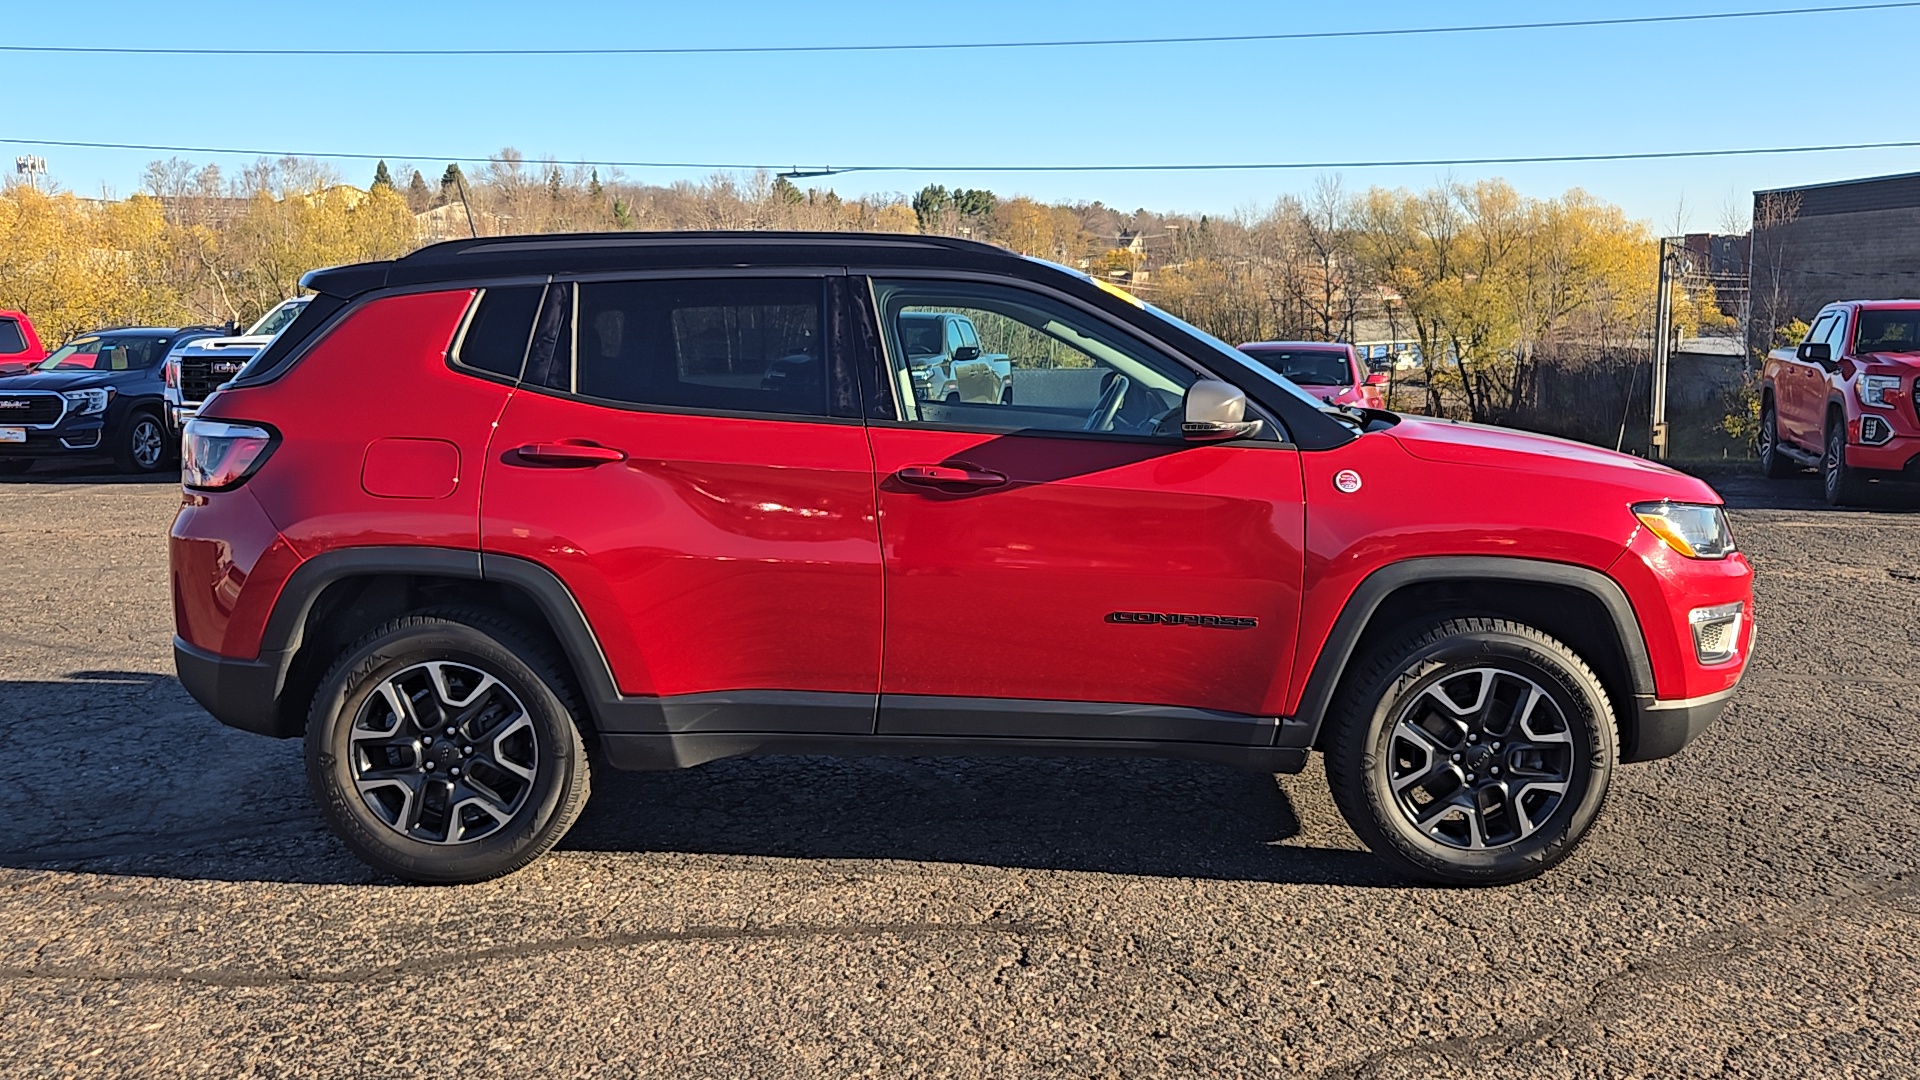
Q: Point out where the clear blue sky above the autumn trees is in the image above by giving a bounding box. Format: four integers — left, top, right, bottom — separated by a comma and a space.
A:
15, 0, 1920, 231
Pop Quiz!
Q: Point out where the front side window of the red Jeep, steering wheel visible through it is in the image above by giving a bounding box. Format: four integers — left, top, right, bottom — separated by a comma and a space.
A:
874, 281, 1200, 438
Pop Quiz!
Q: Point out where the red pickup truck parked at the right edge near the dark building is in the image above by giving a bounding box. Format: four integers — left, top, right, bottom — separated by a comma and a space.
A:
1761, 300, 1920, 505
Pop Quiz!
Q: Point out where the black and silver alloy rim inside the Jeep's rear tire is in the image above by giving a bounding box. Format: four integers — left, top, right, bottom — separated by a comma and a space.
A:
348, 661, 540, 846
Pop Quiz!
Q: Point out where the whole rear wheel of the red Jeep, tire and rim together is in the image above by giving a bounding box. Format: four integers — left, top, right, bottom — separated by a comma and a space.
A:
307, 609, 589, 884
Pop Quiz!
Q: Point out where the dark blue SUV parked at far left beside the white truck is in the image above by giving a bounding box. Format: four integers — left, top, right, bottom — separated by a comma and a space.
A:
0, 327, 219, 475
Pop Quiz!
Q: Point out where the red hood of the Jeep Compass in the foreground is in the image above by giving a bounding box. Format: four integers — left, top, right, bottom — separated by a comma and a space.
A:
1386, 415, 1720, 503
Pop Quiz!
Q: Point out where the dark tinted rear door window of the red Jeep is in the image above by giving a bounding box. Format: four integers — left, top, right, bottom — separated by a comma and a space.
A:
572, 279, 828, 415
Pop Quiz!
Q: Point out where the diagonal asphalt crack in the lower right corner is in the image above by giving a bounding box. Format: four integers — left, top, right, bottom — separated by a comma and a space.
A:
1319, 874, 1920, 1080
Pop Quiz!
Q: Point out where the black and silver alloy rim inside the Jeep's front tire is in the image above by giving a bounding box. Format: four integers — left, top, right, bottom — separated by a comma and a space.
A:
1386, 667, 1574, 851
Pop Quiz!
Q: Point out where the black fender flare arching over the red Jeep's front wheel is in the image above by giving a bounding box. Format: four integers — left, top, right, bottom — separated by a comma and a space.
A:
1283, 555, 1655, 749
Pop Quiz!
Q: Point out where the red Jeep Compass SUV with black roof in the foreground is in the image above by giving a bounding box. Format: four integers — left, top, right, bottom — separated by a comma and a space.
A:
171, 233, 1753, 884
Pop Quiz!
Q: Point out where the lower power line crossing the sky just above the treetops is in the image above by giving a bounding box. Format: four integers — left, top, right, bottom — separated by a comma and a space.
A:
0, 138, 1920, 177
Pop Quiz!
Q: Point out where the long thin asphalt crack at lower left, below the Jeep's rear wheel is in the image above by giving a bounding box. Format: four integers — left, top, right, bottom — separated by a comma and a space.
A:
0, 920, 1060, 988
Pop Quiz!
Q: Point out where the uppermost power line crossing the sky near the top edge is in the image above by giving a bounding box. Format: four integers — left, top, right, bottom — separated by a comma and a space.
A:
0, 0, 1920, 56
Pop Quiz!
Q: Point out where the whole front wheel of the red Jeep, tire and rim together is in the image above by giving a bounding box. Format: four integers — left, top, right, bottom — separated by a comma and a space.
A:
1325, 619, 1620, 886
